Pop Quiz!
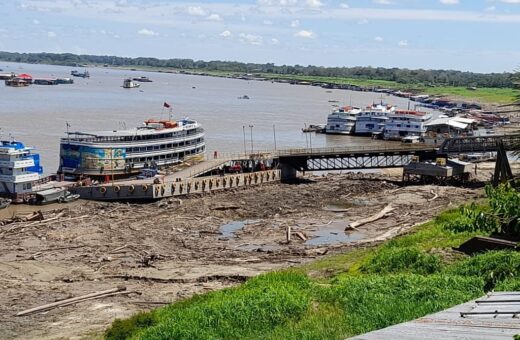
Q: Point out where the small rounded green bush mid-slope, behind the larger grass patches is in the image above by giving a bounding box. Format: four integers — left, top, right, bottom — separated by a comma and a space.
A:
361, 247, 442, 274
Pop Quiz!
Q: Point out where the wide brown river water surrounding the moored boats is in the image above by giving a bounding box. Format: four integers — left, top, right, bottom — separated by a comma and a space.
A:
0, 62, 438, 174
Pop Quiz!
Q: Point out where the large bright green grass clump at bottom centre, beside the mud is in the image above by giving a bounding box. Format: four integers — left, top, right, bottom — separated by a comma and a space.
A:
107, 272, 310, 339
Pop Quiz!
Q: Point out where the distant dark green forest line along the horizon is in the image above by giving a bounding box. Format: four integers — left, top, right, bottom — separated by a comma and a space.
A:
0, 51, 513, 88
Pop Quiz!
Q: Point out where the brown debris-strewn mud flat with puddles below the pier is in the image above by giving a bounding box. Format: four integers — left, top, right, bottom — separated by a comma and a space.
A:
0, 173, 483, 339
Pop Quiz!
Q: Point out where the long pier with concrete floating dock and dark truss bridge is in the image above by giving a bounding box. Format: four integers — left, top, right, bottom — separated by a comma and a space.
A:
72, 134, 520, 201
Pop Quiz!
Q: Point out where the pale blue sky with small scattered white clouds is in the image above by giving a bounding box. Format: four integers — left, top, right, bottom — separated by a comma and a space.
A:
0, 0, 520, 73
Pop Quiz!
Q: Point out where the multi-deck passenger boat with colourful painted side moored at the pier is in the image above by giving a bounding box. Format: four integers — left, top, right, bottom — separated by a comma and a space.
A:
58, 115, 206, 179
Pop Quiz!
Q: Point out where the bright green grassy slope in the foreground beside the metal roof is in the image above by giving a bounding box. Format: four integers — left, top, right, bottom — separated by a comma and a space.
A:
106, 205, 520, 339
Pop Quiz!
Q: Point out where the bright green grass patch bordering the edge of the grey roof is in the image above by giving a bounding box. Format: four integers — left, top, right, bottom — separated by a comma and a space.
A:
324, 274, 483, 335
